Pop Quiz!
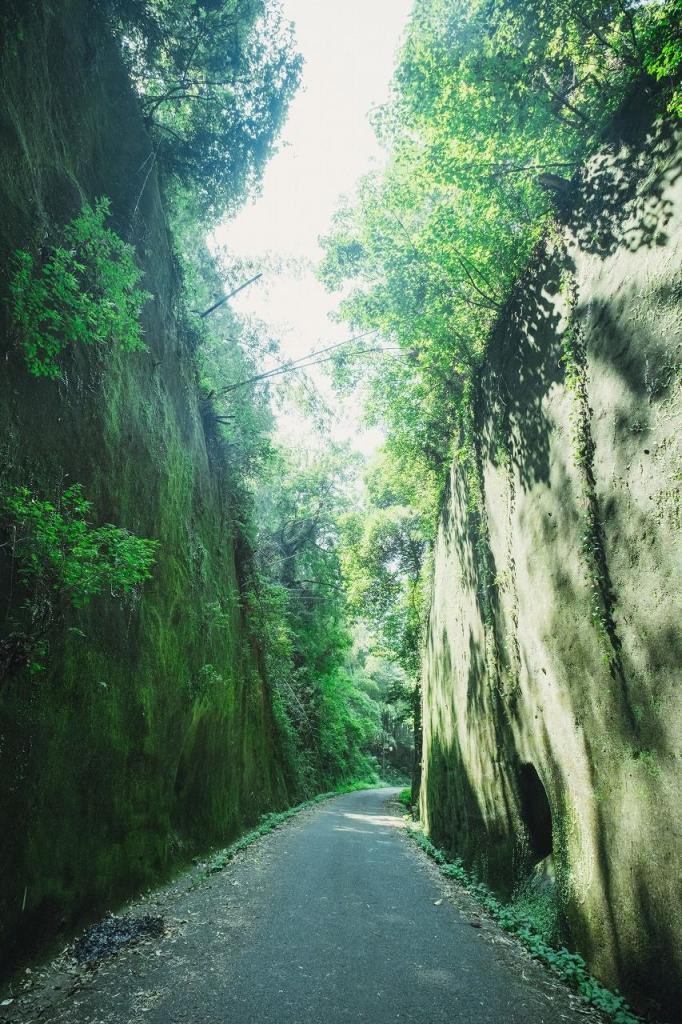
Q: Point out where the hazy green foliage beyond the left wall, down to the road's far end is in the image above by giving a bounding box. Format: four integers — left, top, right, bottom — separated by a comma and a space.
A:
166, 220, 412, 796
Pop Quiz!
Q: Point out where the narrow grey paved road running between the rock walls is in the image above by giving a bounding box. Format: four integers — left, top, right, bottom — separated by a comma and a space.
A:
7, 790, 591, 1024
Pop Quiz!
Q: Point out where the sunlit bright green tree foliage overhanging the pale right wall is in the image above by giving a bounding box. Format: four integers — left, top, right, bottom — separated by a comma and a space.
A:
321, 0, 681, 477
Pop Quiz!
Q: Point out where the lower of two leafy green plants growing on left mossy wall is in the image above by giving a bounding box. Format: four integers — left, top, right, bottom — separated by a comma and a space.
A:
0, 483, 157, 680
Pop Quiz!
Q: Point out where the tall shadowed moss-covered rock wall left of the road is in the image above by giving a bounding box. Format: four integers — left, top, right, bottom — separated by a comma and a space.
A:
0, 0, 287, 963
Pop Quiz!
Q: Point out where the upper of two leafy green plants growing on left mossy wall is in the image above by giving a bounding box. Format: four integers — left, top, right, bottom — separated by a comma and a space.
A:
9, 198, 152, 379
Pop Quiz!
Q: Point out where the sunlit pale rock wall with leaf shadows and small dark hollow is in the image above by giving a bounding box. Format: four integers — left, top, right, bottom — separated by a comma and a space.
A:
421, 101, 682, 1014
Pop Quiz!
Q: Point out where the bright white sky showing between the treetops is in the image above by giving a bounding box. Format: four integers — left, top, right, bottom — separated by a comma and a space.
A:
215, 0, 413, 452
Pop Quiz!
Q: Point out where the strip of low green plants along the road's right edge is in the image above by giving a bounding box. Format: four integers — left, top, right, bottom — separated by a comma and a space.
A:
398, 819, 642, 1024
